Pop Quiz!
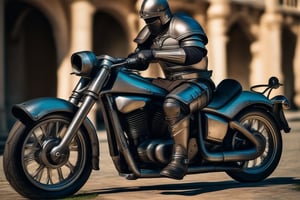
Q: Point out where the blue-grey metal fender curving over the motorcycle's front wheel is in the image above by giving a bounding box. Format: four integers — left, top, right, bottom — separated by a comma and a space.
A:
12, 97, 99, 170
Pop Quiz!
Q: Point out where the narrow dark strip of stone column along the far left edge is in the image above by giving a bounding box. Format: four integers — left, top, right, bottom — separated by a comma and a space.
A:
0, 1, 7, 141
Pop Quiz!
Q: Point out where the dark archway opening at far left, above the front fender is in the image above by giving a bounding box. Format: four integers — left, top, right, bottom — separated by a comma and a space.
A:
5, 1, 57, 125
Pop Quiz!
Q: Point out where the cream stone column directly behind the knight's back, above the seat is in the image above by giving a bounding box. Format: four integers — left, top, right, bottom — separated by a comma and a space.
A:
207, 0, 230, 84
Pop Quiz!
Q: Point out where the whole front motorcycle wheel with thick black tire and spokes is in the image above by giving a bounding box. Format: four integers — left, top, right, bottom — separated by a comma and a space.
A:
3, 114, 92, 199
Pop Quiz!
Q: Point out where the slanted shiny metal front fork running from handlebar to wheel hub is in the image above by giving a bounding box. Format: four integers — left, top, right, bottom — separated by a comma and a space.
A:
50, 66, 109, 161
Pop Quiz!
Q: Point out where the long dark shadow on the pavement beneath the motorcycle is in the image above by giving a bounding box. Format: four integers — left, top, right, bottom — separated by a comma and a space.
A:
73, 177, 300, 197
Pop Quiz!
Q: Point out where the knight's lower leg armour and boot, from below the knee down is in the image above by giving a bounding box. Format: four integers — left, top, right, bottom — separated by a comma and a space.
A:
160, 117, 189, 180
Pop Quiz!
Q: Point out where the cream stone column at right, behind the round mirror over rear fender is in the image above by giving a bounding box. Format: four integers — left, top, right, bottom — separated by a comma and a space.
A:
256, 0, 284, 95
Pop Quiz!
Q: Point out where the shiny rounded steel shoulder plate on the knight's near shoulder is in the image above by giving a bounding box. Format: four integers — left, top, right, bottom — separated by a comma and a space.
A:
169, 13, 208, 45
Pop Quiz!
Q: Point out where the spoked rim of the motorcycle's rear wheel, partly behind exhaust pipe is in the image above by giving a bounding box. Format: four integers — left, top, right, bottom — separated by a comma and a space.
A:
233, 116, 278, 173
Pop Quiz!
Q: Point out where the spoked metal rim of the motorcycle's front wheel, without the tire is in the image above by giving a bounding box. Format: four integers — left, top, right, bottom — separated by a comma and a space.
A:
22, 118, 87, 191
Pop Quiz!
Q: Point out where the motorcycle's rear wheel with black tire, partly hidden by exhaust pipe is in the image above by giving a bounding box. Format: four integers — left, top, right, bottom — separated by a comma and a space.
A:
226, 109, 282, 182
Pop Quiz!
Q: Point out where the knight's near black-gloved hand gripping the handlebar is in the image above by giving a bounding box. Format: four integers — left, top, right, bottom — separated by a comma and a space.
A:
127, 50, 154, 70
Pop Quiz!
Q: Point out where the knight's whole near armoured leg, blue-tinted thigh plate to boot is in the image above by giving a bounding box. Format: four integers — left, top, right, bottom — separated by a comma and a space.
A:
160, 83, 208, 179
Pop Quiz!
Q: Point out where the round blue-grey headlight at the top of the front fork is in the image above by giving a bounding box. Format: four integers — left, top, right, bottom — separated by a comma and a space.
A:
71, 51, 98, 77
